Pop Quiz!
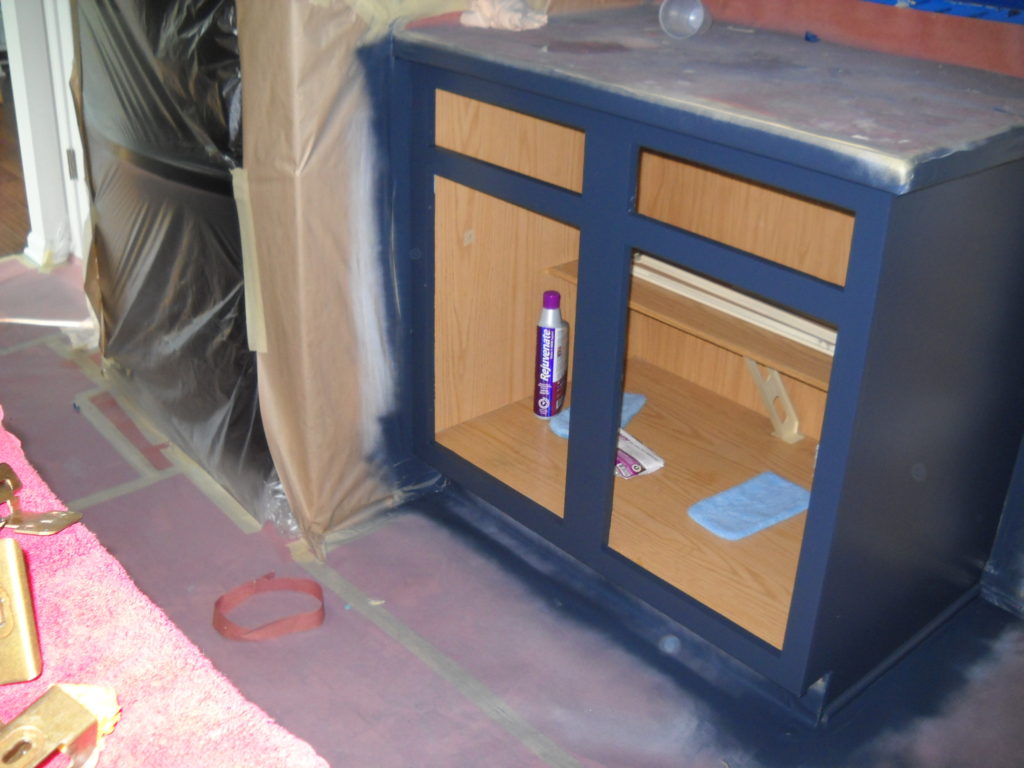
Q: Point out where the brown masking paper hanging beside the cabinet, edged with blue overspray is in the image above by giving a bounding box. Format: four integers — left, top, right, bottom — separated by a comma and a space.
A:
237, 0, 643, 549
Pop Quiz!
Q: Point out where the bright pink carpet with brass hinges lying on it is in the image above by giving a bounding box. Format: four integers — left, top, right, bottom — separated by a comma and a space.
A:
0, 409, 328, 768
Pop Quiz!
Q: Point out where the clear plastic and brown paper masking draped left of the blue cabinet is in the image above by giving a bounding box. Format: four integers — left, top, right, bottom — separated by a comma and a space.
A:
78, 0, 643, 549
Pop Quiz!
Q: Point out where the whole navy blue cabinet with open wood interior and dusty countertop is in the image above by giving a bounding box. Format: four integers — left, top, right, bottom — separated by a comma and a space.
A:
393, 8, 1024, 707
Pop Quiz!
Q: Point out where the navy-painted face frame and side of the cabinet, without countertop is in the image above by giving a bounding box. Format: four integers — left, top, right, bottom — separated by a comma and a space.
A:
392, 39, 1024, 720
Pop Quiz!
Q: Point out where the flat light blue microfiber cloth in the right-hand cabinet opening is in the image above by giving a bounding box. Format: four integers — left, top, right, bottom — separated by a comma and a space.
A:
689, 472, 811, 541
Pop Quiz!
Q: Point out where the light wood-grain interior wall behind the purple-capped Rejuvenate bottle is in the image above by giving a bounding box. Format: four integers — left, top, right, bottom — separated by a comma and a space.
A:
434, 177, 580, 432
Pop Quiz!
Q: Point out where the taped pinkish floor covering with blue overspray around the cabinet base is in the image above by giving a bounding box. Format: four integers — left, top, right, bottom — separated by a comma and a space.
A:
0, 259, 1024, 768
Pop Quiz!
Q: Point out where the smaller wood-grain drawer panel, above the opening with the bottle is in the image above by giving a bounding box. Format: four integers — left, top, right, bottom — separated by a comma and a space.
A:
434, 90, 584, 193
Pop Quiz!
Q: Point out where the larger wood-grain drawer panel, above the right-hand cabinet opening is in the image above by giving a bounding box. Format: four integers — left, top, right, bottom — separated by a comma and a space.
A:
637, 151, 854, 286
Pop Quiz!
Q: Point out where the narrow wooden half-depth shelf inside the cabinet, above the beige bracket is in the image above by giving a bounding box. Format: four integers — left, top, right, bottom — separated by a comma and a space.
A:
549, 261, 831, 391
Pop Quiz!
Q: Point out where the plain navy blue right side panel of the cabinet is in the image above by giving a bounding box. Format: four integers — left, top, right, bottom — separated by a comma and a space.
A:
805, 162, 1024, 696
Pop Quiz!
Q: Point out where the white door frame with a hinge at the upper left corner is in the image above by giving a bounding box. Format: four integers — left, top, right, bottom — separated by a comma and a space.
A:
3, 0, 91, 266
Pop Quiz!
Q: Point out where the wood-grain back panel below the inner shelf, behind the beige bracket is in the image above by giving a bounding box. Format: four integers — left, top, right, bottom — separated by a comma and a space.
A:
629, 312, 827, 440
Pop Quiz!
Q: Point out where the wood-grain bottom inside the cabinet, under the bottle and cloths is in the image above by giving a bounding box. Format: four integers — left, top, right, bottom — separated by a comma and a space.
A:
436, 359, 815, 648
